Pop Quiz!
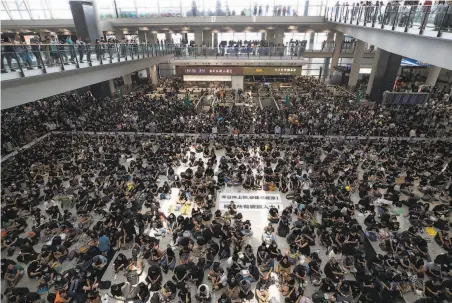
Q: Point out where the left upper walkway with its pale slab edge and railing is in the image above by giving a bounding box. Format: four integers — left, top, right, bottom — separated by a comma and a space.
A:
1, 44, 174, 109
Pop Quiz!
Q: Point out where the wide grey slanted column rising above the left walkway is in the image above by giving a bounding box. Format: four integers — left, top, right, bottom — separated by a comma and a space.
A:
69, 0, 102, 42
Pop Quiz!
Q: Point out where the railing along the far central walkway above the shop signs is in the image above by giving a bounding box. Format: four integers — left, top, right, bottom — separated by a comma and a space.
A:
174, 42, 375, 60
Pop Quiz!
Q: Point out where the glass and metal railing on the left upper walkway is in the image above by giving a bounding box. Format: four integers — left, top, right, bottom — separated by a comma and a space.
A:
1, 43, 174, 80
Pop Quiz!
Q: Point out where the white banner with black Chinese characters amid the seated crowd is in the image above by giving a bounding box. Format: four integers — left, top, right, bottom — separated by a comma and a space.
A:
219, 193, 284, 212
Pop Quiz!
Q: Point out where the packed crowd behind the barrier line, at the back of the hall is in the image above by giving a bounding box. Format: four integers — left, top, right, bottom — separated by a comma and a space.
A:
2, 77, 451, 154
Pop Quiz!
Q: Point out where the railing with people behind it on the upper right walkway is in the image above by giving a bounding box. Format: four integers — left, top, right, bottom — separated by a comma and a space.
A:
325, 4, 452, 37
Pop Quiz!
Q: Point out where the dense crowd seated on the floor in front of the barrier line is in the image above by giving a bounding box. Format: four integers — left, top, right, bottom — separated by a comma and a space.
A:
1, 127, 452, 303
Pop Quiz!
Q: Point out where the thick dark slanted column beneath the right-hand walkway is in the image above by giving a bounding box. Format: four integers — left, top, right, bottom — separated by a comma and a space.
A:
370, 49, 402, 103
